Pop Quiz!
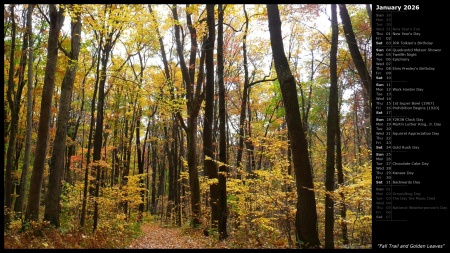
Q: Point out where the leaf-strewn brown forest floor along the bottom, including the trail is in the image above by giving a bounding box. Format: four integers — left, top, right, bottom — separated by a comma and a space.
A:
3, 220, 287, 249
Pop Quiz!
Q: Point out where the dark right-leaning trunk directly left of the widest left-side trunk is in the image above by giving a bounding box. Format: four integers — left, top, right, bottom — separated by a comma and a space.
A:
25, 4, 64, 221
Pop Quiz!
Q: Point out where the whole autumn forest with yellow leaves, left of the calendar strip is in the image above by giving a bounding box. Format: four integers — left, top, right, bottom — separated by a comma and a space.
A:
3, 4, 370, 249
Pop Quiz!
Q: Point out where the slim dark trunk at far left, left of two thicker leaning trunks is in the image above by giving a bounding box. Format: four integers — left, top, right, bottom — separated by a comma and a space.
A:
16, 4, 34, 221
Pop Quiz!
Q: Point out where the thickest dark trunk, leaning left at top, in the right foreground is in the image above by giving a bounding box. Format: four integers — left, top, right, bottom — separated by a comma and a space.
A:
267, 4, 320, 248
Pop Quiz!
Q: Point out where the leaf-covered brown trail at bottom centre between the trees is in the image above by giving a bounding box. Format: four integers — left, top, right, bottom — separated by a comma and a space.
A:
128, 223, 217, 249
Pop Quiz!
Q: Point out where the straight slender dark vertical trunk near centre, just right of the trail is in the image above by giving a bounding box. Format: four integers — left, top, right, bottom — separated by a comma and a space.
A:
217, 4, 228, 240
